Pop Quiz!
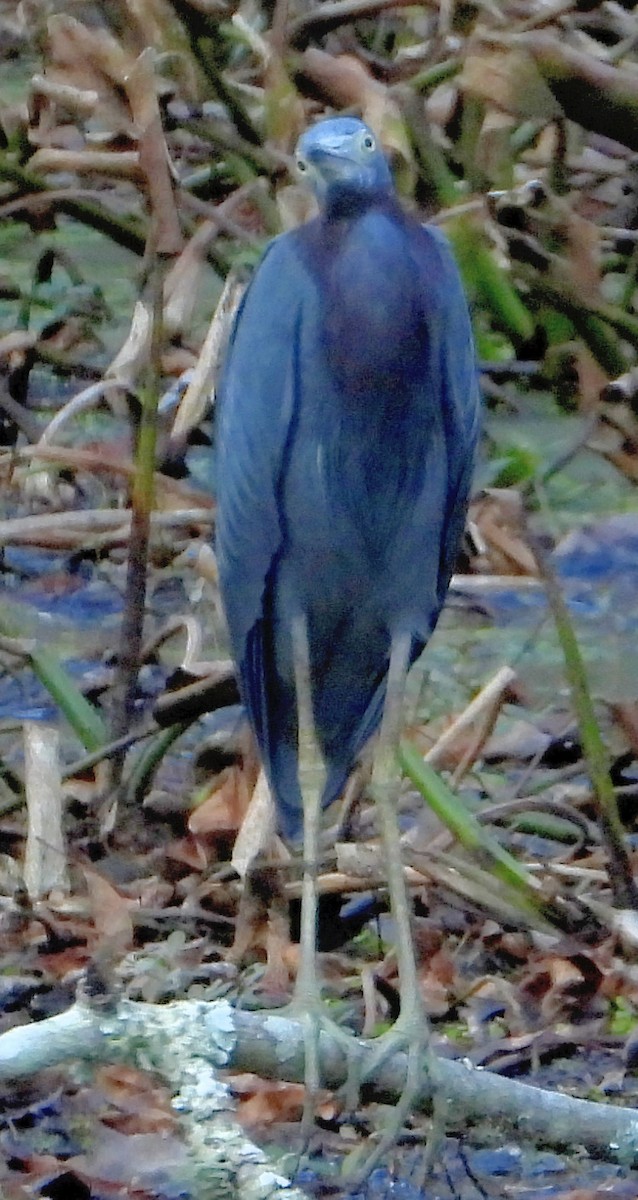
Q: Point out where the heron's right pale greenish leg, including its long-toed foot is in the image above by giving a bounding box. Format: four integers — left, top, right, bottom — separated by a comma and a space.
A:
348, 635, 438, 1175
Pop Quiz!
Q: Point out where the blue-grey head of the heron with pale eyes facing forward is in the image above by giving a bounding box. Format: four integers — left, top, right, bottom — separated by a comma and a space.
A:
295, 116, 392, 202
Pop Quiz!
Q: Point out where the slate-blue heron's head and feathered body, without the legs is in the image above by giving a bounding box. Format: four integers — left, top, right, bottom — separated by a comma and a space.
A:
217, 119, 479, 838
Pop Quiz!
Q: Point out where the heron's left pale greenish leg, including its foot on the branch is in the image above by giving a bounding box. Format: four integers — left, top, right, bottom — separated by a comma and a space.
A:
291, 617, 356, 1134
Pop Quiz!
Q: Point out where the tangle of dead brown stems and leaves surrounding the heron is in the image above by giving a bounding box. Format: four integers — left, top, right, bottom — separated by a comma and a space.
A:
0, 0, 638, 1196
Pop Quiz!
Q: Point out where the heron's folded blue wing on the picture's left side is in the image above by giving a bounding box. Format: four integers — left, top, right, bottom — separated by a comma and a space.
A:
216, 235, 307, 827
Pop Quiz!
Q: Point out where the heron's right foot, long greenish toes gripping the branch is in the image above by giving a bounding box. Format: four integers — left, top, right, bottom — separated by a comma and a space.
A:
343, 1006, 440, 1186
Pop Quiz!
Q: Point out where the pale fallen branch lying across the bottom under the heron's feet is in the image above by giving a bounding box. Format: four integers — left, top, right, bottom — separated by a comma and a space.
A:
0, 1000, 638, 1171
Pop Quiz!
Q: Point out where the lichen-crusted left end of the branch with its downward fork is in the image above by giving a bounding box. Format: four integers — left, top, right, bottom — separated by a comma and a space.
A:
0, 1002, 303, 1200
